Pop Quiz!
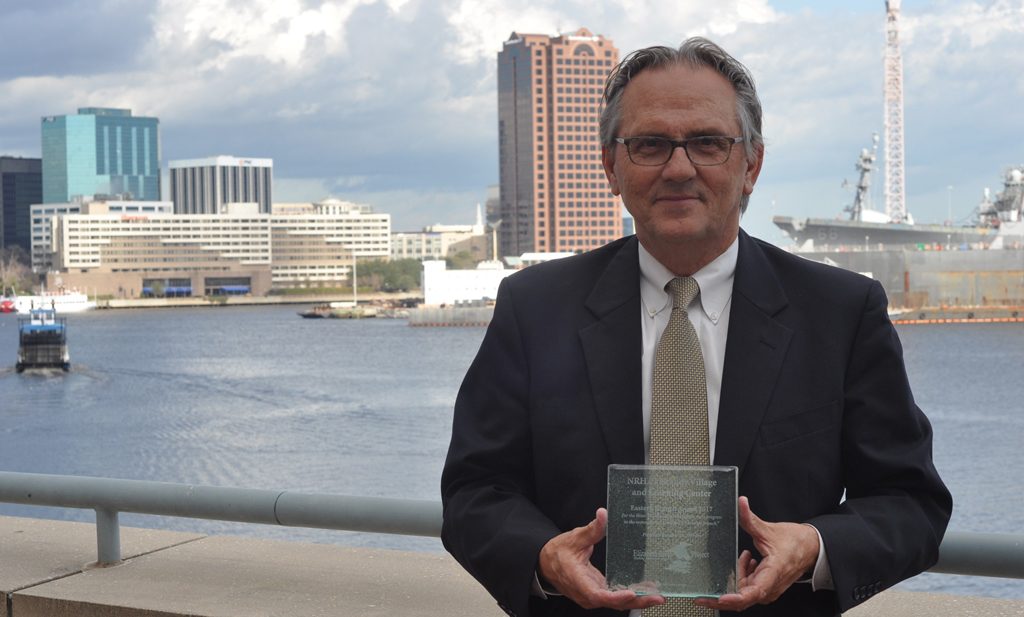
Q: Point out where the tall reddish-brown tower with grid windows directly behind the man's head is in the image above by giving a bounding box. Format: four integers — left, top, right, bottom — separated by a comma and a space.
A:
498, 28, 623, 255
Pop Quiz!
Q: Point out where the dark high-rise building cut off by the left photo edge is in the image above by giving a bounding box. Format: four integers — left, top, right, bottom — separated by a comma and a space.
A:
0, 157, 43, 255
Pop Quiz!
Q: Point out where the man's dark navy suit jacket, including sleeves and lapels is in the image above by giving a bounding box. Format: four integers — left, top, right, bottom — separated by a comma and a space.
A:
441, 231, 951, 617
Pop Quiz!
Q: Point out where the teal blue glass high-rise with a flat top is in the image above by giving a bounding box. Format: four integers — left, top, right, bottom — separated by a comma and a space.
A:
42, 107, 160, 204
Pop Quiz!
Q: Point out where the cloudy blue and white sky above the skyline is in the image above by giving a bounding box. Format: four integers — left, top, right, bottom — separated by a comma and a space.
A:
0, 0, 1024, 243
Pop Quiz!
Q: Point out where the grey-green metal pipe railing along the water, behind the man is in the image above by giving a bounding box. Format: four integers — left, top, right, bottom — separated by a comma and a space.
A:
0, 472, 1024, 578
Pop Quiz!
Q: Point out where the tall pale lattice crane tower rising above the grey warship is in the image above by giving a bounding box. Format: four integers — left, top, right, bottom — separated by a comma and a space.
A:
885, 0, 907, 223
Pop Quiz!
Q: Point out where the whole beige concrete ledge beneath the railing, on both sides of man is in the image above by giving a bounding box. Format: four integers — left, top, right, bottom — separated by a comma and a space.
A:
0, 517, 1024, 617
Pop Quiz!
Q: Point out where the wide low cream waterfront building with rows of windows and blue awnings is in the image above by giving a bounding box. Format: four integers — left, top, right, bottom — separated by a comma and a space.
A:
47, 201, 391, 298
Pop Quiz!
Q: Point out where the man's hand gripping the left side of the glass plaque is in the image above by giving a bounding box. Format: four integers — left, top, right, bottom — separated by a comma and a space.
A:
538, 508, 665, 611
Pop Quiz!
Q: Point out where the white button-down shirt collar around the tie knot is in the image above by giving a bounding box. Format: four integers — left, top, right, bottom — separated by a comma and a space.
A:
639, 236, 739, 323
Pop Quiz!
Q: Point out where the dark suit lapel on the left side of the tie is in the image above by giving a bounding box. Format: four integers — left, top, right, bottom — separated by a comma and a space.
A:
580, 237, 644, 465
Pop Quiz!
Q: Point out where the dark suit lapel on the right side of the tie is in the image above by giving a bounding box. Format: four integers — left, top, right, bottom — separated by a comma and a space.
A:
715, 230, 793, 476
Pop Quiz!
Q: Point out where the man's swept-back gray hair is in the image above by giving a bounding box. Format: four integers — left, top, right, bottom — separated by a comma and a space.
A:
600, 37, 764, 163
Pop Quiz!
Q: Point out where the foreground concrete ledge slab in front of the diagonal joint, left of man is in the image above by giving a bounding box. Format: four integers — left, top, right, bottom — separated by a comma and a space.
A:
11, 521, 504, 617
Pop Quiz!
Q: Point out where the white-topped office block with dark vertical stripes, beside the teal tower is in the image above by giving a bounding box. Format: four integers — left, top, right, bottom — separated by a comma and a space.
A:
170, 157, 273, 214
